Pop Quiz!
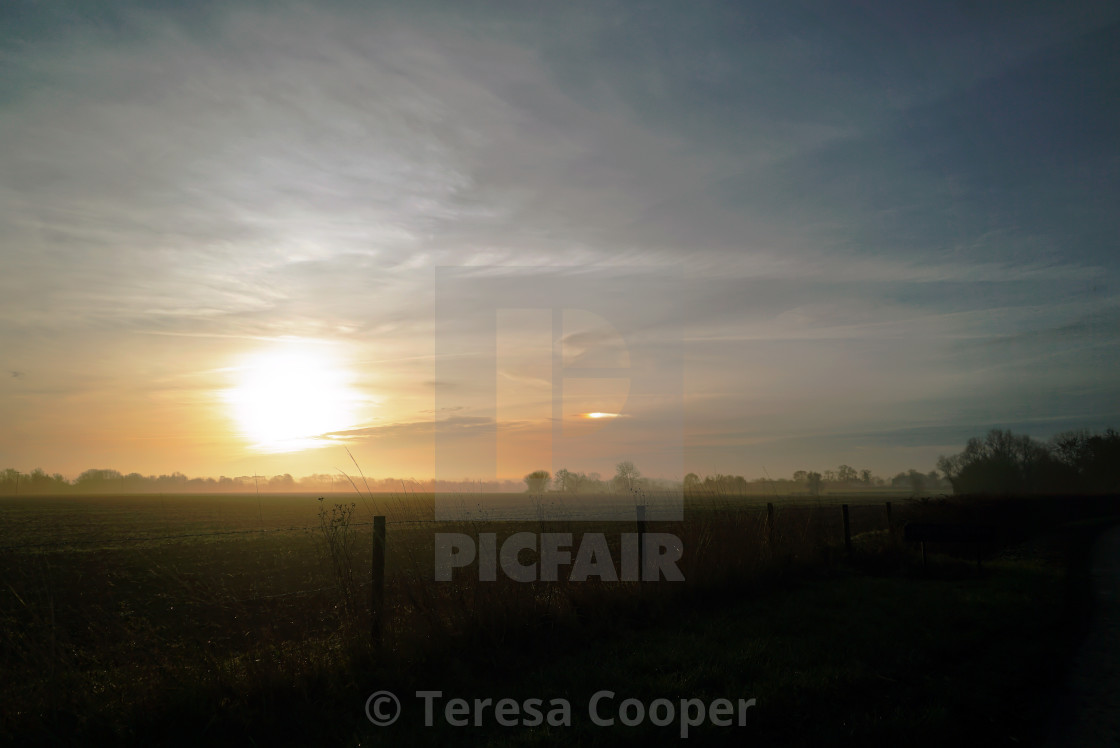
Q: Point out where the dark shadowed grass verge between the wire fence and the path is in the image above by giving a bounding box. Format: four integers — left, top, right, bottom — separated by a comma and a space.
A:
356, 562, 1065, 746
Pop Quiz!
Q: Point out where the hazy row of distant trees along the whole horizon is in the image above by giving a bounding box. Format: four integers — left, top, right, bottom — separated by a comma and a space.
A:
0, 429, 1120, 496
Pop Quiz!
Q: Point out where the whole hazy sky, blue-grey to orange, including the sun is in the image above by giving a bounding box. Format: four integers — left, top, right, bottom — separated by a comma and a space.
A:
0, 0, 1120, 478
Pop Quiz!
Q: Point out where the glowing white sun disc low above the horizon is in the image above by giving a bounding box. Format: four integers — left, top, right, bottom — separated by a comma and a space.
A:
224, 346, 362, 452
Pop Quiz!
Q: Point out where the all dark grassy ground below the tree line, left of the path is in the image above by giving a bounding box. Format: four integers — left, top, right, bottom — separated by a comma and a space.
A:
0, 496, 1118, 746
